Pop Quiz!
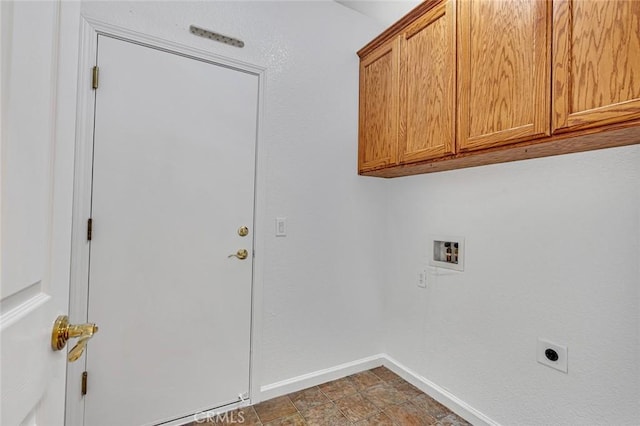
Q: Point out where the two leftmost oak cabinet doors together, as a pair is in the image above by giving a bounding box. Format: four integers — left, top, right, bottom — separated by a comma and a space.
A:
358, 1, 456, 173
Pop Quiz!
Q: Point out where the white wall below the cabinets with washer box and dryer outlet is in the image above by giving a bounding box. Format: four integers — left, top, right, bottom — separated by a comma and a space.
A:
385, 146, 640, 425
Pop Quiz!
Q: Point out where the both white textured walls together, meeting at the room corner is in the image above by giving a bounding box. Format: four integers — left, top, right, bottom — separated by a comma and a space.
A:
70, 2, 640, 425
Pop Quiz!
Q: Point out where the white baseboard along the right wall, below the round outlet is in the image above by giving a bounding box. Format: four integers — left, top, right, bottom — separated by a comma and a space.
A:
381, 354, 500, 426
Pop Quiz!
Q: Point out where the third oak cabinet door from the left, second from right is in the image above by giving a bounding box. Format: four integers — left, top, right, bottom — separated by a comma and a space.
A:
458, 0, 551, 151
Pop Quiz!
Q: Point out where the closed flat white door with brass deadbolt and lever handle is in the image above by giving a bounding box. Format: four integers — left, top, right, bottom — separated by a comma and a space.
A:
85, 36, 258, 426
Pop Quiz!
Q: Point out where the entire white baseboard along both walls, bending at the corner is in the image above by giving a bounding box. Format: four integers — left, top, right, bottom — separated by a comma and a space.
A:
258, 354, 500, 426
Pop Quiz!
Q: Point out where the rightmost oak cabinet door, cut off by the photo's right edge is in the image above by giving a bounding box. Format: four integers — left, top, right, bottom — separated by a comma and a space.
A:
553, 0, 640, 131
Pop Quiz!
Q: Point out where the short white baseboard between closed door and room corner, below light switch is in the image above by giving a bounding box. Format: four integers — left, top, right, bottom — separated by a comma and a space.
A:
258, 354, 385, 404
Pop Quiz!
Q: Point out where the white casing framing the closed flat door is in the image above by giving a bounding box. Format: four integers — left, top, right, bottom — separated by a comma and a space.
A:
65, 17, 266, 426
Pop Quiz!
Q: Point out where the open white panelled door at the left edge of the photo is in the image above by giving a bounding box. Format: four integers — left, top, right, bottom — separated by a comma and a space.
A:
0, 1, 80, 426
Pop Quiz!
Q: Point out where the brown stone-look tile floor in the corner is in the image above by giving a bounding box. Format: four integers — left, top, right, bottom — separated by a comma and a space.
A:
184, 367, 470, 426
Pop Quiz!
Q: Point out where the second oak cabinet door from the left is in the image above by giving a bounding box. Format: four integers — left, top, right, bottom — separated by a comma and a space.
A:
398, 0, 456, 163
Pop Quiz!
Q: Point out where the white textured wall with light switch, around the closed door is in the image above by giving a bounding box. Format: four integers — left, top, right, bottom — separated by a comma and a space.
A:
82, 1, 384, 385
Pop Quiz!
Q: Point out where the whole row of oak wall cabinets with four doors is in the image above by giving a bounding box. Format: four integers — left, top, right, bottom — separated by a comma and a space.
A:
358, 0, 640, 177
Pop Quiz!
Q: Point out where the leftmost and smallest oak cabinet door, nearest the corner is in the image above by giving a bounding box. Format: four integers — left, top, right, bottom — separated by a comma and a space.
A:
358, 38, 400, 172
